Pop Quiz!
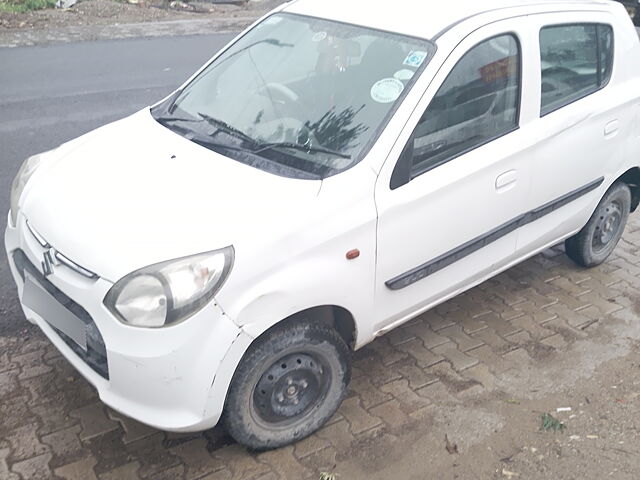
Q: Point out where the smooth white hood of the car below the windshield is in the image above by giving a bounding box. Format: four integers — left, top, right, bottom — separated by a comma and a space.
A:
22, 110, 321, 281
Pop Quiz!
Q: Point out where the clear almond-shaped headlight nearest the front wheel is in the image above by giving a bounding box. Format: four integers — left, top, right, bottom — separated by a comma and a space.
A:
104, 247, 234, 328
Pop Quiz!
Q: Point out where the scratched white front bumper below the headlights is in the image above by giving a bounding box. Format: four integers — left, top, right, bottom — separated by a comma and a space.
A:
5, 216, 247, 431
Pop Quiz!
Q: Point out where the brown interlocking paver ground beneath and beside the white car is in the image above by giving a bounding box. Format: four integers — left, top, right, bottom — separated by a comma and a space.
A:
0, 215, 640, 480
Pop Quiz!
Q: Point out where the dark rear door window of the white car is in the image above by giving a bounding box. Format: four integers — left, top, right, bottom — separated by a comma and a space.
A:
540, 24, 613, 115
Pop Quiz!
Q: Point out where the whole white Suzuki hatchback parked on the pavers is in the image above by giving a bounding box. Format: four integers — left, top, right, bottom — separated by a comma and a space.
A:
5, 0, 640, 449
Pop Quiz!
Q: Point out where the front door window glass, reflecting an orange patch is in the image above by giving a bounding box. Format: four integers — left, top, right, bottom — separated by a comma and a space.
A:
411, 35, 520, 177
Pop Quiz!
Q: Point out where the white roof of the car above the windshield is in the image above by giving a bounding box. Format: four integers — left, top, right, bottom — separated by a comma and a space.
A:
284, 0, 616, 39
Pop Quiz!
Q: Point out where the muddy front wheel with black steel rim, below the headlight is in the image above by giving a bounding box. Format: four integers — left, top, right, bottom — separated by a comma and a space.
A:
222, 321, 351, 450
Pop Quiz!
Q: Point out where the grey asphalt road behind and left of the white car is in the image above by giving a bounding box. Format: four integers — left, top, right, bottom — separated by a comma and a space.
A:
0, 34, 232, 335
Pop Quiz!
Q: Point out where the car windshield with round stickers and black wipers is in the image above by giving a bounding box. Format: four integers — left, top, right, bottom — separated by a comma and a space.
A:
152, 13, 435, 178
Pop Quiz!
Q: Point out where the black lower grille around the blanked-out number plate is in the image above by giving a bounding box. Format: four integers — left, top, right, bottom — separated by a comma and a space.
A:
13, 249, 109, 380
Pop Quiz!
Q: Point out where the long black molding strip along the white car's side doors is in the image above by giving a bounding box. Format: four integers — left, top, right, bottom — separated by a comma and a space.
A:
385, 177, 604, 290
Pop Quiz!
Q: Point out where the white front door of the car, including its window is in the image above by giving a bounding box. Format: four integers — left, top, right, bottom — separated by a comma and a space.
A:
375, 20, 534, 332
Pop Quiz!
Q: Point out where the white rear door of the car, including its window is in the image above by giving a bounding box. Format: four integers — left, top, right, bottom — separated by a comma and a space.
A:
518, 12, 634, 255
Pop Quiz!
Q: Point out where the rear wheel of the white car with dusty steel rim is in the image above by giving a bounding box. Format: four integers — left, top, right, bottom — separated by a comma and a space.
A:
565, 182, 631, 268
